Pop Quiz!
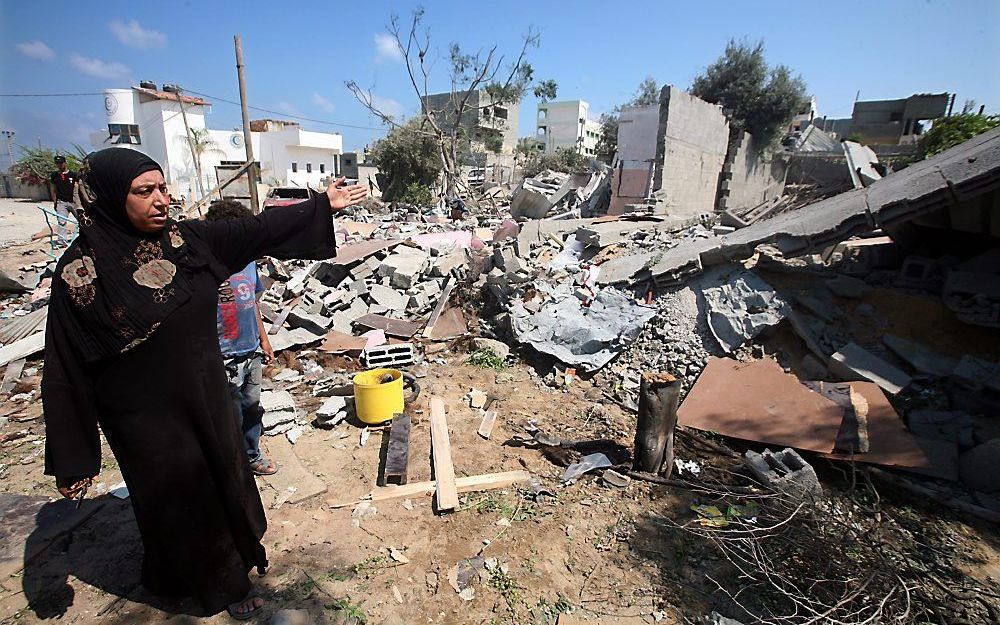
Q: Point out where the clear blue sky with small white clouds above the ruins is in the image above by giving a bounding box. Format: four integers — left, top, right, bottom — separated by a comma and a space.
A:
0, 0, 1000, 156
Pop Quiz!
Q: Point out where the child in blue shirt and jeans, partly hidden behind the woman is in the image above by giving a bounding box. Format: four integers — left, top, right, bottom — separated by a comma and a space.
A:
205, 200, 278, 475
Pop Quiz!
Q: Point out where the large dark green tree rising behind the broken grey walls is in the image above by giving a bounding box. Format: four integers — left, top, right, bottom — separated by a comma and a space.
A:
691, 39, 806, 145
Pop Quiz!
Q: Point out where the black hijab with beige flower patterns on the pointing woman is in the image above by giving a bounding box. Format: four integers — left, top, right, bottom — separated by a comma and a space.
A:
49, 148, 225, 361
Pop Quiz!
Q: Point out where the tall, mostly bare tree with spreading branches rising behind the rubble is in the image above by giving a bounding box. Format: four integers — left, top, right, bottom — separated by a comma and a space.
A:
346, 8, 556, 196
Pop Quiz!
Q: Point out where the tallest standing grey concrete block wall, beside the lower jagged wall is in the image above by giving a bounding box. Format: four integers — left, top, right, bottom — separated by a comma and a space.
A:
653, 85, 729, 216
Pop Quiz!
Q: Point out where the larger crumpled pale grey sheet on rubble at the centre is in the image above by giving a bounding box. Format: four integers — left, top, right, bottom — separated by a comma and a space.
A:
511, 285, 656, 371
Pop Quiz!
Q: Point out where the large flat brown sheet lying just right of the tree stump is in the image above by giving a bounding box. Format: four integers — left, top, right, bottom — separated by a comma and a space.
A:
677, 357, 848, 453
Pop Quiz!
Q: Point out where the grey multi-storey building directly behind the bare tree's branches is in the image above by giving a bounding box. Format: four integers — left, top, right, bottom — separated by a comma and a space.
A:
420, 89, 520, 154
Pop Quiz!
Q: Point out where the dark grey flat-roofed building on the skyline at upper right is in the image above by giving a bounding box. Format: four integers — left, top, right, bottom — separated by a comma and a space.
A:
813, 93, 955, 145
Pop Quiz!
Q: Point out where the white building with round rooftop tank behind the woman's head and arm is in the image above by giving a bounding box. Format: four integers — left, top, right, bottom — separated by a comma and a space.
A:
90, 83, 343, 199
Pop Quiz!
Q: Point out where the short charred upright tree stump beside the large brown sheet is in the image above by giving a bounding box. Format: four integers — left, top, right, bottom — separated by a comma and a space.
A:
632, 372, 681, 477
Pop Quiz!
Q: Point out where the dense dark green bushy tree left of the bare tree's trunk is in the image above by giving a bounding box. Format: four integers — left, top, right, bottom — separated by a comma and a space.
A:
371, 117, 441, 201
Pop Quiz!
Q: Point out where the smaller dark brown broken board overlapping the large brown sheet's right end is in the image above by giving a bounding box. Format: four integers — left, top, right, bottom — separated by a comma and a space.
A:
823, 382, 958, 481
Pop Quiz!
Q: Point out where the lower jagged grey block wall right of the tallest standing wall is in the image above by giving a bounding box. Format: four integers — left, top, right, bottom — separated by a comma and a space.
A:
718, 132, 788, 211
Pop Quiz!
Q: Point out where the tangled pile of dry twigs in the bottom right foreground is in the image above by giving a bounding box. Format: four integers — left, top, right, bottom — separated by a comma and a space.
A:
657, 464, 997, 625
